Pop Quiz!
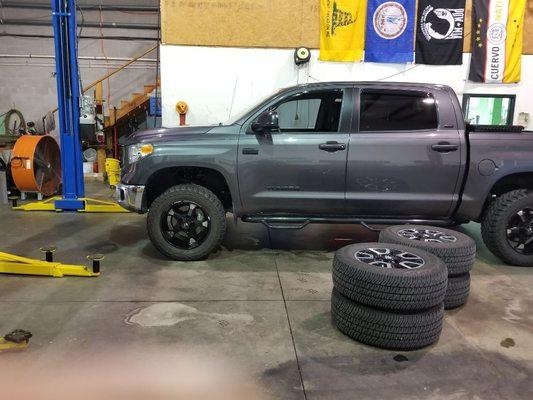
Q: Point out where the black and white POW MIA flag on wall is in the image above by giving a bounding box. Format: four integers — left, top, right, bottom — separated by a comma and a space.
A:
415, 0, 465, 65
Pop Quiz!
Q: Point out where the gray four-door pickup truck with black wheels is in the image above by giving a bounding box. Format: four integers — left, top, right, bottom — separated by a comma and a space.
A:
117, 82, 533, 266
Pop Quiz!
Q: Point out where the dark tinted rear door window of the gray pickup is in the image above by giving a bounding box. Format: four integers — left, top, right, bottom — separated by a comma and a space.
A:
360, 91, 438, 132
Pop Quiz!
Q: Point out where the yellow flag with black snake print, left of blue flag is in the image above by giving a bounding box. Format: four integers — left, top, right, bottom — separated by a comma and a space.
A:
319, 0, 366, 61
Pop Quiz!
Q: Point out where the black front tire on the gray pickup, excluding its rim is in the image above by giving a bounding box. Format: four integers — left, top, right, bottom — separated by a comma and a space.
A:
147, 184, 226, 261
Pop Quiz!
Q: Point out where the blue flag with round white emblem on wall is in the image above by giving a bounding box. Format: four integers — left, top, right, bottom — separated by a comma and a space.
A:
365, 0, 416, 63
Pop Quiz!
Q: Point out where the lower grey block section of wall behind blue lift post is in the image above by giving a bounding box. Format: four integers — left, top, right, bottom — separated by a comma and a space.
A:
0, 38, 156, 126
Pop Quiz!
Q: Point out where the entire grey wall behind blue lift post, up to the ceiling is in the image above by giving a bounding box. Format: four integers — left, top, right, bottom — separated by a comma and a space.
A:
0, 0, 159, 131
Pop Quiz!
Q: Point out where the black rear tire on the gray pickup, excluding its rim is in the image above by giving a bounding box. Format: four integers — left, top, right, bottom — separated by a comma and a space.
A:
481, 189, 533, 267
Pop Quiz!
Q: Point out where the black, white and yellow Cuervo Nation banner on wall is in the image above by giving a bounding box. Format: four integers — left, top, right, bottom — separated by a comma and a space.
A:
468, 0, 526, 83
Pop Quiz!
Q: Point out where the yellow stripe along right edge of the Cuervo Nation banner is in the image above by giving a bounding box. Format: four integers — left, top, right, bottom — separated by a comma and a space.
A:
503, 0, 526, 83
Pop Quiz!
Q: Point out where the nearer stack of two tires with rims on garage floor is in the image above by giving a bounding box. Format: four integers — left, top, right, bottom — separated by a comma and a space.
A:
331, 243, 448, 350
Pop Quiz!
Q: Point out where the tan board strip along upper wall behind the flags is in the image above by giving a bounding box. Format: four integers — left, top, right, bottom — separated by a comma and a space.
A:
161, 0, 533, 54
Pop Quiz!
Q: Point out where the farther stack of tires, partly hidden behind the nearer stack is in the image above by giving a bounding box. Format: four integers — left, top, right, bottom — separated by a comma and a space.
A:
379, 225, 476, 310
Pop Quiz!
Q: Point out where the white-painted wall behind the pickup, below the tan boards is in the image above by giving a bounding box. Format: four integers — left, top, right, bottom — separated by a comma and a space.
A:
161, 45, 533, 129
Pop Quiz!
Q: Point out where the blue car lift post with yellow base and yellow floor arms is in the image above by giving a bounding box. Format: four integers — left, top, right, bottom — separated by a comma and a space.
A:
0, 0, 119, 276
